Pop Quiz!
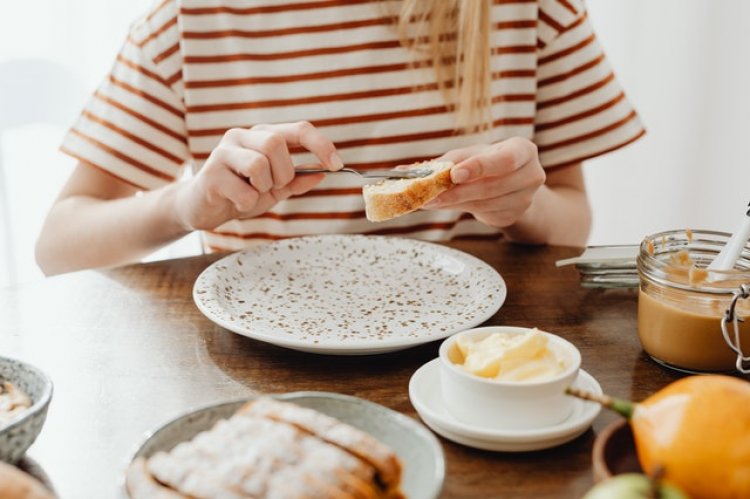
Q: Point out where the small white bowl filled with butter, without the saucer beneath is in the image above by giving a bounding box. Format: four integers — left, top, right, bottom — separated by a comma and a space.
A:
439, 326, 581, 430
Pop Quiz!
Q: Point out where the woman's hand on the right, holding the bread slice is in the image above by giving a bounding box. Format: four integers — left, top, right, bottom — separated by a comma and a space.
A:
424, 137, 546, 228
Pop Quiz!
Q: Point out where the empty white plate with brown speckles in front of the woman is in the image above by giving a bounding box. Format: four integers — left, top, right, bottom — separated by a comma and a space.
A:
193, 235, 506, 354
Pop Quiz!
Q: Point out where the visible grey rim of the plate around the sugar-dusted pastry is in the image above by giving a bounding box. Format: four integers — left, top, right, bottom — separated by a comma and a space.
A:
122, 392, 445, 499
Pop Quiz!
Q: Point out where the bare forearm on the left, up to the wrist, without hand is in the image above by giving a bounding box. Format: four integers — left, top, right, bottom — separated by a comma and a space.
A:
36, 184, 188, 275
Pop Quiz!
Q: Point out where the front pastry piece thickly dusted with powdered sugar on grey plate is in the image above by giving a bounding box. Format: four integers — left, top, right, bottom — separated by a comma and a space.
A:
148, 414, 374, 499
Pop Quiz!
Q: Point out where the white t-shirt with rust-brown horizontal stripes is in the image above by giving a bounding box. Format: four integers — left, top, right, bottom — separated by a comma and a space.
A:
62, 0, 644, 249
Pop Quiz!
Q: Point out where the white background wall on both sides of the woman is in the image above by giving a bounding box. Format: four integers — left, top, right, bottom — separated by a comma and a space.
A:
0, 0, 750, 286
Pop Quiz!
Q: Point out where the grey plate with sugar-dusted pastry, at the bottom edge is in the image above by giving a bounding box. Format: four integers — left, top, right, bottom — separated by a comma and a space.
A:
124, 392, 445, 499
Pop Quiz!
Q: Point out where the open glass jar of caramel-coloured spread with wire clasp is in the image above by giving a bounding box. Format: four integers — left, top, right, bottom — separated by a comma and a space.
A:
637, 230, 750, 372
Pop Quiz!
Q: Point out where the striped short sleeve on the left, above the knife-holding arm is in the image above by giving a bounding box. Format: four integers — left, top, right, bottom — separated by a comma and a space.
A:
61, 0, 189, 190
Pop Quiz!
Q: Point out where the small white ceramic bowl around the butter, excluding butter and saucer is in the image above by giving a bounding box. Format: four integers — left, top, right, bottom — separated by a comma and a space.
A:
440, 326, 581, 430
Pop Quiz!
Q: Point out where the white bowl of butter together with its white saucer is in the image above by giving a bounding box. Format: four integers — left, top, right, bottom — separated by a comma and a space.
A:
409, 326, 602, 452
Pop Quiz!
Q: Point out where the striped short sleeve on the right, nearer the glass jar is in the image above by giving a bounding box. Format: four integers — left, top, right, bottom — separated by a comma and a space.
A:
534, 0, 645, 168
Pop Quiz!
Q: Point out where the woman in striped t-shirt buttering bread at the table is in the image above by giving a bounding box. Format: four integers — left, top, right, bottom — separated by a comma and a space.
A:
37, 0, 644, 274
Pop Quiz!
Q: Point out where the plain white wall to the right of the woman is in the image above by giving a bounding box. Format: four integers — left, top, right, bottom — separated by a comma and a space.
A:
586, 0, 750, 244
